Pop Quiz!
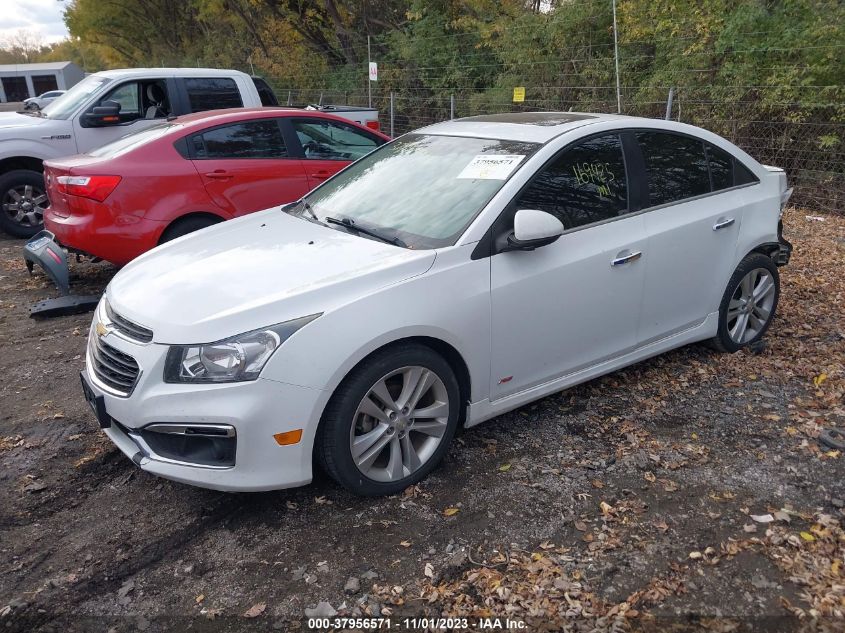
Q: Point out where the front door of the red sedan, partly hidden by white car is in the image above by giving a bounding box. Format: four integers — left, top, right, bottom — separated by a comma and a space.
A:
284, 115, 385, 189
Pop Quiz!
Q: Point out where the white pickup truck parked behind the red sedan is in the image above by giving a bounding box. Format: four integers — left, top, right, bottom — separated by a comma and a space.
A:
0, 68, 268, 237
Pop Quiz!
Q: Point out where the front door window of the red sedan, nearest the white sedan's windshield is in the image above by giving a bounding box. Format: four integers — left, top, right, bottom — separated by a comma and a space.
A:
292, 117, 385, 161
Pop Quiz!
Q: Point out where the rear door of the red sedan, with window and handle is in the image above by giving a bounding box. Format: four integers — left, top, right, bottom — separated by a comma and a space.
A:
188, 117, 309, 217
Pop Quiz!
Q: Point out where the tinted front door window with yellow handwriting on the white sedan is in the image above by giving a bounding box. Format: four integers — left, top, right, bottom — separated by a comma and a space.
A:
516, 134, 628, 229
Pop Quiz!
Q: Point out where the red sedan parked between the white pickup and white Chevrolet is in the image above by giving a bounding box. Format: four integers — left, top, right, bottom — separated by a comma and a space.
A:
44, 108, 389, 266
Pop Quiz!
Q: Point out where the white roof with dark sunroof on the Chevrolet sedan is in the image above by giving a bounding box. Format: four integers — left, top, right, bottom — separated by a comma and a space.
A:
417, 112, 637, 143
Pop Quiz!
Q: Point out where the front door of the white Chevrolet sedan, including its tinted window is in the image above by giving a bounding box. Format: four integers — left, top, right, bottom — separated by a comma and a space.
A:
490, 133, 648, 400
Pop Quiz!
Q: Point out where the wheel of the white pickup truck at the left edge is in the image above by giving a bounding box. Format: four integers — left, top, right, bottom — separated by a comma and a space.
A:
0, 169, 49, 237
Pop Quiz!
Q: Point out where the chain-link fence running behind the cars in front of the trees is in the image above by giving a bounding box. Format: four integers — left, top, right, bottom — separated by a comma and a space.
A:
274, 85, 845, 213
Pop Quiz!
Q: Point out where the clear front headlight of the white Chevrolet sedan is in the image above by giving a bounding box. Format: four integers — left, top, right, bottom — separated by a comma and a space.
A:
164, 314, 320, 383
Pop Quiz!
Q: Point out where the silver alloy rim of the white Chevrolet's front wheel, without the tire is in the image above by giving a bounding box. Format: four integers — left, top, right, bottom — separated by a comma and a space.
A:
349, 366, 450, 482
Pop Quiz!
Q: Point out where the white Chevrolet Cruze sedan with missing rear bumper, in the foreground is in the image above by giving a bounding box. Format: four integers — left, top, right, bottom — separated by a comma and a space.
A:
82, 113, 791, 495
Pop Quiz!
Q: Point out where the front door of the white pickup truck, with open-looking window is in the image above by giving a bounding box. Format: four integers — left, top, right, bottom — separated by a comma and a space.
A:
73, 77, 179, 154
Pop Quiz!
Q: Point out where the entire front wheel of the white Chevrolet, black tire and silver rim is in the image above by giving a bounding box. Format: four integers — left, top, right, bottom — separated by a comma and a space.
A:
316, 343, 460, 496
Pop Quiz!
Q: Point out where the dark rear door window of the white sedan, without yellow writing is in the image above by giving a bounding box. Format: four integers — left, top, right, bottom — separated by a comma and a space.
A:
636, 132, 711, 207
